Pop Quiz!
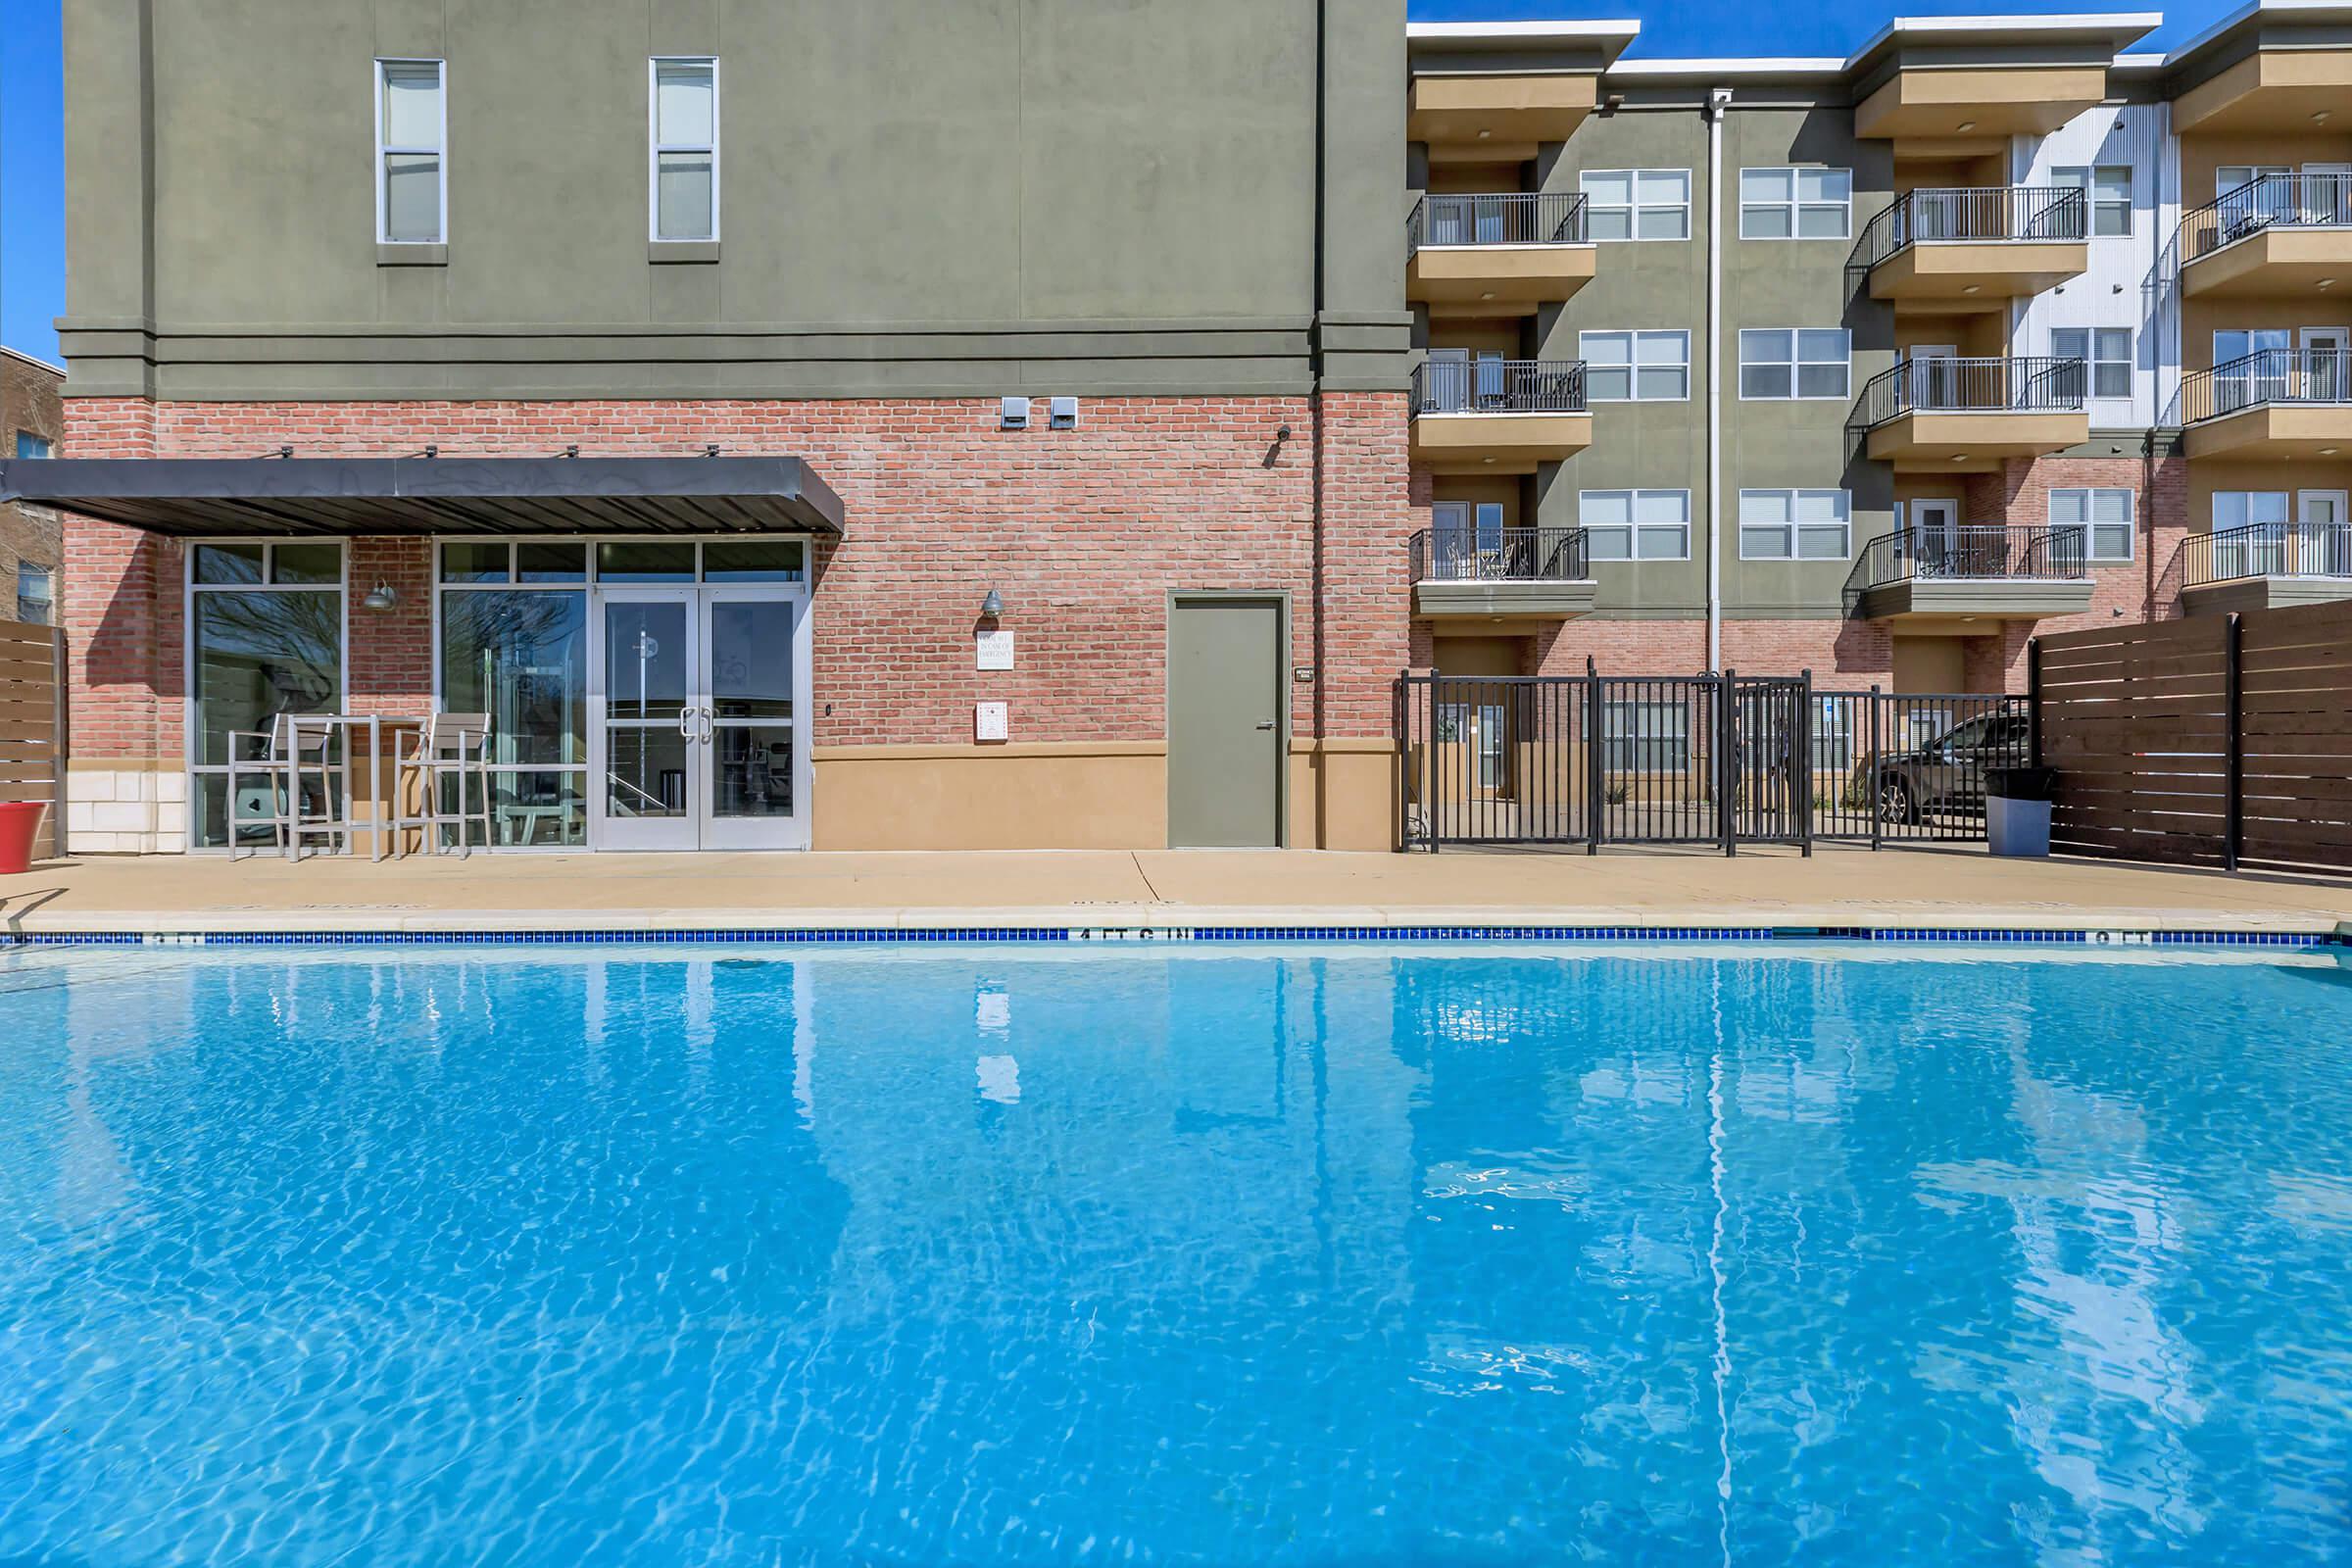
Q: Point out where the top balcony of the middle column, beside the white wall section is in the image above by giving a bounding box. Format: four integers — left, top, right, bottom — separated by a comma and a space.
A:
1848, 186, 2091, 315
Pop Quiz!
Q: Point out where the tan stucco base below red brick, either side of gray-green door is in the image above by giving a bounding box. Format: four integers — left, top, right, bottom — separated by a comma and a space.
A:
811, 741, 1395, 849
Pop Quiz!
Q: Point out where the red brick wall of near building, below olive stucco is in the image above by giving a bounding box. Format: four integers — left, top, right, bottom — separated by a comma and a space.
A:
69, 393, 1413, 757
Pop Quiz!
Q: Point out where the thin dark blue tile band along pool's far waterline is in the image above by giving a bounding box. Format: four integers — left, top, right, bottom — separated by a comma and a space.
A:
0, 924, 2352, 953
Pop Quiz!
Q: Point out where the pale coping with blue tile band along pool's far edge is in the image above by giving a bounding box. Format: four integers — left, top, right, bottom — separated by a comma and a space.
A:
0, 907, 2352, 953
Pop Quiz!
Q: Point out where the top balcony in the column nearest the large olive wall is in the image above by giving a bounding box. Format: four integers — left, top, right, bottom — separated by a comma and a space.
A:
1404, 190, 1594, 315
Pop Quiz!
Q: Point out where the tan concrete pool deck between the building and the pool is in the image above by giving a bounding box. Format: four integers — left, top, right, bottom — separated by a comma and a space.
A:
0, 847, 2352, 941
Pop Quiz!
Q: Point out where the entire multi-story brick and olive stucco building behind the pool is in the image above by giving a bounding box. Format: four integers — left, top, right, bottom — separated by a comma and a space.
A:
5, 0, 2352, 849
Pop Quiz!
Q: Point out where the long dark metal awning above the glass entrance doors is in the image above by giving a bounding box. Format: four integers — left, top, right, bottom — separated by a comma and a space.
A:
0, 459, 842, 536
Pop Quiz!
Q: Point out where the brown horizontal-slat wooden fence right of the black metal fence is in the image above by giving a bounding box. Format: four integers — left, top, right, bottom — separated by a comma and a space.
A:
2030, 604, 2352, 874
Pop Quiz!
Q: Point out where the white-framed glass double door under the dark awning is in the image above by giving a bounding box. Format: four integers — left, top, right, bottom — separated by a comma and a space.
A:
588, 585, 809, 851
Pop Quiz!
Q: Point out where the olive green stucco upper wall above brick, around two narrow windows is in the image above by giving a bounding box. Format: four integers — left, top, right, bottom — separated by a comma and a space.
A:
64, 0, 1406, 397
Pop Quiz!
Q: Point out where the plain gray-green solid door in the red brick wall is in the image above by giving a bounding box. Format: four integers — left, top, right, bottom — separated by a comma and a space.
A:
1169, 600, 1287, 849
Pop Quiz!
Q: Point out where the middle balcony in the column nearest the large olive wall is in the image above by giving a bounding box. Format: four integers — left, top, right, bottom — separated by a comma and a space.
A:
1411, 360, 1592, 472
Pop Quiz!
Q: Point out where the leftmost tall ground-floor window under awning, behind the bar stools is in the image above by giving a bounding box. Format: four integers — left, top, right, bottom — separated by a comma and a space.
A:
188, 541, 343, 849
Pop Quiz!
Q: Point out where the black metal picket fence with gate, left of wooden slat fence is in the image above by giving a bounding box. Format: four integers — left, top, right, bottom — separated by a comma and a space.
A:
1395, 672, 2030, 854
